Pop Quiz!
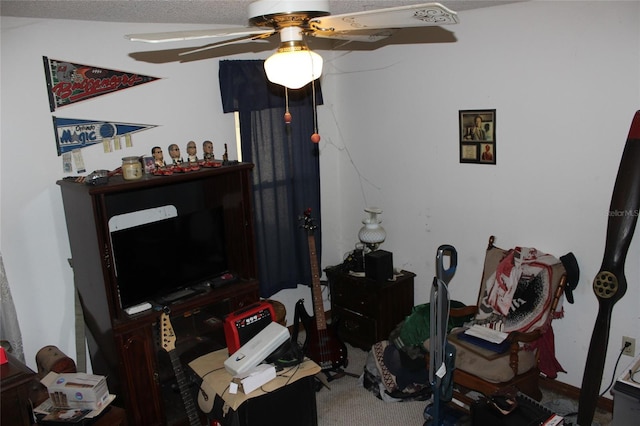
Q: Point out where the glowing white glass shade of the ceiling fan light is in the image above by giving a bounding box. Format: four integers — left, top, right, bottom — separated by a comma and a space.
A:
264, 49, 322, 89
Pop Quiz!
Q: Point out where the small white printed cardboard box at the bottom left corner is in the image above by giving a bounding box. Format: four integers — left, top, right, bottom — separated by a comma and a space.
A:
41, 372, 109, 410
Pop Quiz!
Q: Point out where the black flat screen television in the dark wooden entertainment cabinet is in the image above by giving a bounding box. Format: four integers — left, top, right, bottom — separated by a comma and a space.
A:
111, 207, 228, 309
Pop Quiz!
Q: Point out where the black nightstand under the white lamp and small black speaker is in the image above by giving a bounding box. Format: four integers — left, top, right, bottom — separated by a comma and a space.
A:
325, 266, 416, 351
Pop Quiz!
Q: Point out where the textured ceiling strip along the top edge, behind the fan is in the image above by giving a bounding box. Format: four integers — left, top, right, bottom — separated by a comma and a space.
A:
0, 0, 522, 26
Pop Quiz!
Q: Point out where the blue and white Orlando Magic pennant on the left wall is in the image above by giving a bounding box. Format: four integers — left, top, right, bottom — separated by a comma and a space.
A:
53, 117, 157, 156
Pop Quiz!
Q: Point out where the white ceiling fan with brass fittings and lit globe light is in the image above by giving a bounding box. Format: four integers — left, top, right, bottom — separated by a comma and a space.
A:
125, 0, 458, 89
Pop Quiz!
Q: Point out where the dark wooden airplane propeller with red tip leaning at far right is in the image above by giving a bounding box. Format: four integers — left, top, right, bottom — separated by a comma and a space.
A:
578, 111, 640, 426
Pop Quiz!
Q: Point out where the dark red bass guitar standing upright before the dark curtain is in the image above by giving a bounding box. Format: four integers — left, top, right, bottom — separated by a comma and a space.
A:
294, 209, 347, 370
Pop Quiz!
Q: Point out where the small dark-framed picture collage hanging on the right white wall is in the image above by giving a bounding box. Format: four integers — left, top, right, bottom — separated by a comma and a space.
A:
459, 109, 496, 164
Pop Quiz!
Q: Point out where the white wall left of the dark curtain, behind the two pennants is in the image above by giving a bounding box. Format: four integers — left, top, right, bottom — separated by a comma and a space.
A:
0, 17, 245, 367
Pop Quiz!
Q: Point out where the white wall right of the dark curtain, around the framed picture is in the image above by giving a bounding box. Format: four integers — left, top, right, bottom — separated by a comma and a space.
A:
320, 2, 640, 389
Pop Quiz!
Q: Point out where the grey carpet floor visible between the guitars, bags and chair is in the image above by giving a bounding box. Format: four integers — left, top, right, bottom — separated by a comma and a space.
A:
316, 345, 611, 426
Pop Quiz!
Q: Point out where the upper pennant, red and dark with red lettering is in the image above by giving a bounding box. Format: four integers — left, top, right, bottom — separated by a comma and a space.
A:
42, 56, 159, 112
